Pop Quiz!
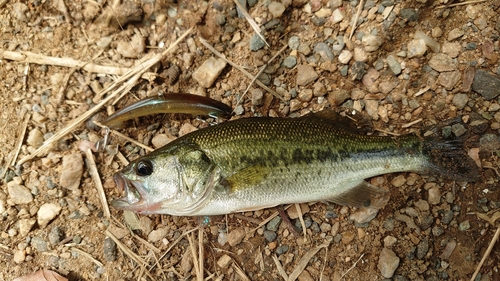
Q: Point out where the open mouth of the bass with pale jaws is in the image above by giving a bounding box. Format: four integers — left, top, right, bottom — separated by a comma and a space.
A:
111, 173, 147, 212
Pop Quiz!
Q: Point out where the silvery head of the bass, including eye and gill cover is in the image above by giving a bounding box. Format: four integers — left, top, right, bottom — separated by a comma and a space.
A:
111, 144, 216, 215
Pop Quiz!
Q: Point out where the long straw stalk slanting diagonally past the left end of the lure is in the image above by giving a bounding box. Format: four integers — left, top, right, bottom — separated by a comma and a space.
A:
15, 28, 192, 165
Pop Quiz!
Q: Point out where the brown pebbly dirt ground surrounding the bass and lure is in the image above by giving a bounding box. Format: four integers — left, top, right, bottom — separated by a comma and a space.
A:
0, 0, 500, 281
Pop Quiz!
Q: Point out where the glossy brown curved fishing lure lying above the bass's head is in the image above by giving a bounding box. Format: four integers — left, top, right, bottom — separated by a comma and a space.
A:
102, 93, 231, 128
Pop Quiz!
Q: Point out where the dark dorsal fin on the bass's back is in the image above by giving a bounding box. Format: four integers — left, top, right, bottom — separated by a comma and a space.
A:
301, 108, 373, 134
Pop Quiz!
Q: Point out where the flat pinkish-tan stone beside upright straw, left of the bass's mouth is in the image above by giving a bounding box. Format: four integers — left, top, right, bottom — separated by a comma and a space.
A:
59, 153, 83, 192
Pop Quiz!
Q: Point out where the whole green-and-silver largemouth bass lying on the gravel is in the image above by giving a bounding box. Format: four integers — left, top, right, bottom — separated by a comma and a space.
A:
111, 110, 479, 216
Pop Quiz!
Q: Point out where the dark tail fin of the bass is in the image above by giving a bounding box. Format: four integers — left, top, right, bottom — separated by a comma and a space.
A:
423, 117, 481, 182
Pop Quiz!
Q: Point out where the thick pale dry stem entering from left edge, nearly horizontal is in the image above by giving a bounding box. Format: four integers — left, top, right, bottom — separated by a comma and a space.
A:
0, 49, 129, 75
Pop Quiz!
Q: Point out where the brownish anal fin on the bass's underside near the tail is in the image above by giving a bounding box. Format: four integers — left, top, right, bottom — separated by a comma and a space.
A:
327, 181, 389, 209
